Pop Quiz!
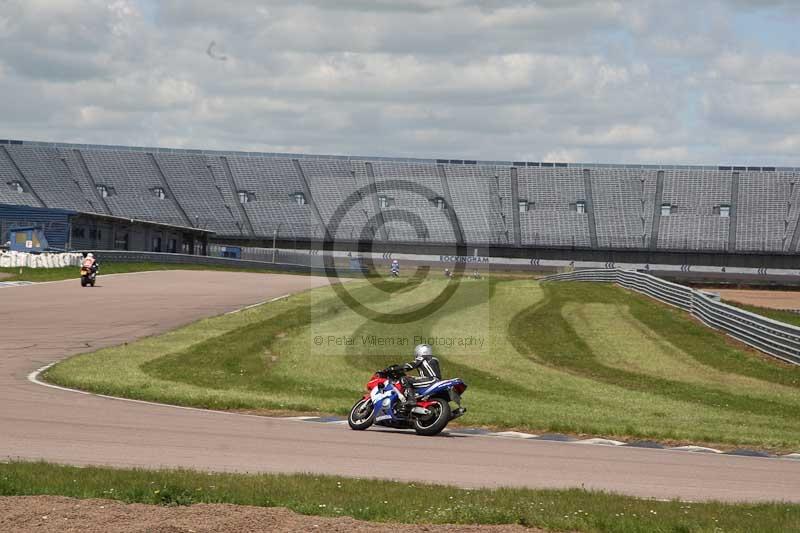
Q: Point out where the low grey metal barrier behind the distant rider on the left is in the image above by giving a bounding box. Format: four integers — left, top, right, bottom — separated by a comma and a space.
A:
83, 250, 362, 275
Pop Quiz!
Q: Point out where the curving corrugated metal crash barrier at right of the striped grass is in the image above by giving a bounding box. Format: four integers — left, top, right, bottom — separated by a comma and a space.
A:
542, 269, 800, 364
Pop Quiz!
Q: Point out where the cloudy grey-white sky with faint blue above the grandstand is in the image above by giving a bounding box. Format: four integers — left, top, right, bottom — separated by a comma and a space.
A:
0, 0, 800, 166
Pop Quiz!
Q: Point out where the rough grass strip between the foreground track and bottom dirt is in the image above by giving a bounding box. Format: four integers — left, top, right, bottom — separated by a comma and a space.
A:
0, 462, 800, 533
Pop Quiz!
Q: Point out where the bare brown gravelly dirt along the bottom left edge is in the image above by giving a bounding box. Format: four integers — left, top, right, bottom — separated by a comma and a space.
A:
0, 496, 543, 533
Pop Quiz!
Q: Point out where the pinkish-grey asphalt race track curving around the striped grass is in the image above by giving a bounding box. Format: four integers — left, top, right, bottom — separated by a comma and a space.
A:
0, 271, 800, 502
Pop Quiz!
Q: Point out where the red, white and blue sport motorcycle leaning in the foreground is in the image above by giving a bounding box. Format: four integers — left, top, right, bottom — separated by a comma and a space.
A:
347, 365, 467, 436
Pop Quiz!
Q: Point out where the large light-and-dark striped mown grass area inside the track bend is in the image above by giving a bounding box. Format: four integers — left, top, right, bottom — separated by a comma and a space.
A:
44, 279, 800, 452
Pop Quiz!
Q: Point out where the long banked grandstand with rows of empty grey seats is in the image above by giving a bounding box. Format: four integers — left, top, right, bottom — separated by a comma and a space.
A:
0, 137, 800, 262
